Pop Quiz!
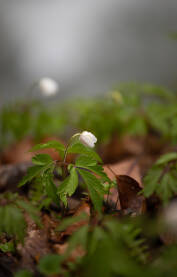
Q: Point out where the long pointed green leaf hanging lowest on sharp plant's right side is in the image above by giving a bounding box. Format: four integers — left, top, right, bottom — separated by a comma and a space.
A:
77, 169, 104, 211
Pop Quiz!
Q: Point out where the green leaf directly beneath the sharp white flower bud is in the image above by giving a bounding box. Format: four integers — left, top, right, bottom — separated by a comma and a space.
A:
68, 142, 102, 162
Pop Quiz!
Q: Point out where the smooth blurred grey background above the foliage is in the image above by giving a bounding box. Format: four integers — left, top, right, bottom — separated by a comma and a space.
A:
0, 0, 177, 104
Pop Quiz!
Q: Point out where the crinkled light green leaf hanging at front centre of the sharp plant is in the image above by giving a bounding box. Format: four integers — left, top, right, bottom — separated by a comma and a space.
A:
58, 167, 78, 206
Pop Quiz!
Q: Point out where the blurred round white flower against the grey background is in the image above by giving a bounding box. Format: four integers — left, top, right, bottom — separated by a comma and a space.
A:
39, 77, 59, 97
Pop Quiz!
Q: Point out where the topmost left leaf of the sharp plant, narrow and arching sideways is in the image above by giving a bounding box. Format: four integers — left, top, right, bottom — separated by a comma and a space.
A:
30, 140, 65, 157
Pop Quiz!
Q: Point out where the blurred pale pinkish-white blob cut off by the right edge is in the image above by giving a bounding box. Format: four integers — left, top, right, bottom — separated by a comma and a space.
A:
163, 200, 177, 230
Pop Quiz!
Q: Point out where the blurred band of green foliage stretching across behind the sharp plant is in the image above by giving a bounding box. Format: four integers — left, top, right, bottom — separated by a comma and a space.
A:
0, 83, 177, 147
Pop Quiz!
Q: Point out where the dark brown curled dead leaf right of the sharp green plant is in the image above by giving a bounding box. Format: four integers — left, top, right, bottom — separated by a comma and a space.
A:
116, 175, 146, 215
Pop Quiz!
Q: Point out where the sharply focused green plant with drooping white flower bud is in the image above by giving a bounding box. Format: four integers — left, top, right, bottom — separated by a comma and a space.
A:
19, 131, 111, 211
